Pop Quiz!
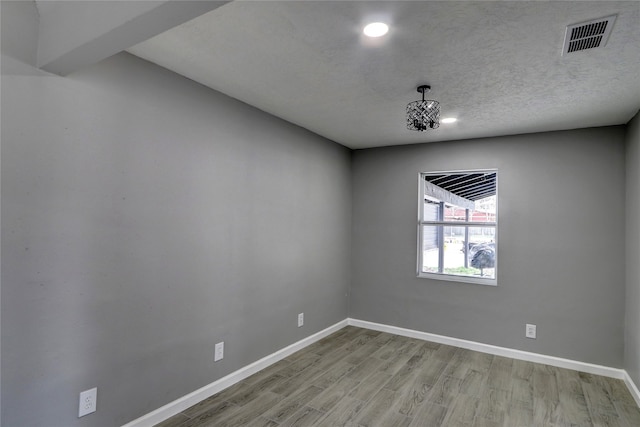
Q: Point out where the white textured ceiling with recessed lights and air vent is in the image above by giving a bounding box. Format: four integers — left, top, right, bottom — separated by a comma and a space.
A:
128, 0, 640, 148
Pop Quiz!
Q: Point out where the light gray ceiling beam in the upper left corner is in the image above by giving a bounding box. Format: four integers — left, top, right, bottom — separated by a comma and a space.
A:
37, 0, 228, 76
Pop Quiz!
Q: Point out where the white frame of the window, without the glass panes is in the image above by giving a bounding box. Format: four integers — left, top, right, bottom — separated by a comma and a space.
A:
416, 169, 499, 286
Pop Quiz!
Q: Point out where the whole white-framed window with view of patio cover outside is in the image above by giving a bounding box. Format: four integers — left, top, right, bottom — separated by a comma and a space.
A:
418, 170, 498, 285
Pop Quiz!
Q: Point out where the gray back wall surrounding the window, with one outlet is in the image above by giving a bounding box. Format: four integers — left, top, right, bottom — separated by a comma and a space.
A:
349, 126, 625, 367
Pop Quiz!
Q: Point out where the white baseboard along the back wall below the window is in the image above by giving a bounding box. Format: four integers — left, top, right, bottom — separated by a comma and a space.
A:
347, 318, 633, 382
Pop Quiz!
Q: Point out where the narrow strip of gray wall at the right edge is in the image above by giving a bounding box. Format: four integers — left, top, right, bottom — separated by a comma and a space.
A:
624, 113, 640, 386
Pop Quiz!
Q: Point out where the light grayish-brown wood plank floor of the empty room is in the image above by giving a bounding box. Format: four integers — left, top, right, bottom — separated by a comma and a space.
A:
156, 326, 640, 427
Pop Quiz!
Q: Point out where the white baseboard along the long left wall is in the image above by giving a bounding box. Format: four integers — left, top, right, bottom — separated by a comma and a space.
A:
122, 319, 347, 427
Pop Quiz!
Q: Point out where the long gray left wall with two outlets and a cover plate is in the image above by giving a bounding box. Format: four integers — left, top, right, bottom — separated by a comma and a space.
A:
1, 2, 351, 427
